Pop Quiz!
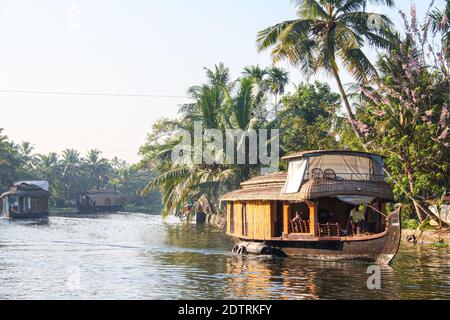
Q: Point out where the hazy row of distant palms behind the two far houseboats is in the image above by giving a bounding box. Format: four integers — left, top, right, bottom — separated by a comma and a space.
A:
0, 131, 160, 211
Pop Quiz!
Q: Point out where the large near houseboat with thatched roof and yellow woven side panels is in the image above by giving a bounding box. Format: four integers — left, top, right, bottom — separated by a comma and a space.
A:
221, 150, 401, 264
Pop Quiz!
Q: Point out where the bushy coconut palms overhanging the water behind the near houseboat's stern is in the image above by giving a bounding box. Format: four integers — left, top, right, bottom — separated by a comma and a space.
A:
144, 66, 274, 215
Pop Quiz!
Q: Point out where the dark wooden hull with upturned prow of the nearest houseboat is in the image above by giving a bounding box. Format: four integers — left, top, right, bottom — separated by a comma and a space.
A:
232, 210, 401, 264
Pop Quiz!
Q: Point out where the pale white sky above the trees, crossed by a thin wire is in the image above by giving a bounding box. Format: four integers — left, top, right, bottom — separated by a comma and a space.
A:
0, 0, 444, 162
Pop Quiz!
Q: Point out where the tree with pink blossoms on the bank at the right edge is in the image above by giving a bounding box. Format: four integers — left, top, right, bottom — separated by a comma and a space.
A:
355, 7, 450, 225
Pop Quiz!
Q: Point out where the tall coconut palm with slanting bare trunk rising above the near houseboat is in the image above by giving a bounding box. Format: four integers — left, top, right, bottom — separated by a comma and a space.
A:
257, 0, 394, 141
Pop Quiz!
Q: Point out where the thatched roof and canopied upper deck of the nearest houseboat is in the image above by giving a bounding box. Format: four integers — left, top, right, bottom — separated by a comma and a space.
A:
221, 150, 394, 202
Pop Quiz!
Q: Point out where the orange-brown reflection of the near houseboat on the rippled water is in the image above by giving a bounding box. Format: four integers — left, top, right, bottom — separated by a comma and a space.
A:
227, 256, 400, 300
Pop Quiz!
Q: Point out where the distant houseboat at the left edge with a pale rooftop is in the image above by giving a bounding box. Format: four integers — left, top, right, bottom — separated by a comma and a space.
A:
1, 181, 50, 219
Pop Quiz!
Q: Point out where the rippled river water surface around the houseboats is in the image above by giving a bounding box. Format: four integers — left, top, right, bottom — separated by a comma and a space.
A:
0, 214, 450, 299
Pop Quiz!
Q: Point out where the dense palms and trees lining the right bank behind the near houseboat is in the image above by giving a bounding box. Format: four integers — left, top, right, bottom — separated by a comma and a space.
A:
141, 0, 450, 227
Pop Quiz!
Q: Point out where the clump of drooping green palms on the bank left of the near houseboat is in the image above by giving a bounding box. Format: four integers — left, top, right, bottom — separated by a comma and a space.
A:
141, 64, 287, 215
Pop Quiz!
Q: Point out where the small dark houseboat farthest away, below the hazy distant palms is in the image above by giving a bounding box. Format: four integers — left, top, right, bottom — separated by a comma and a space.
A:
77, 190, 125, 213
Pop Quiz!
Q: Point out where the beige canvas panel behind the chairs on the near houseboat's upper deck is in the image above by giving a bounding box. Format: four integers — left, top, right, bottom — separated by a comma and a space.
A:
308, 155, 379, 180
